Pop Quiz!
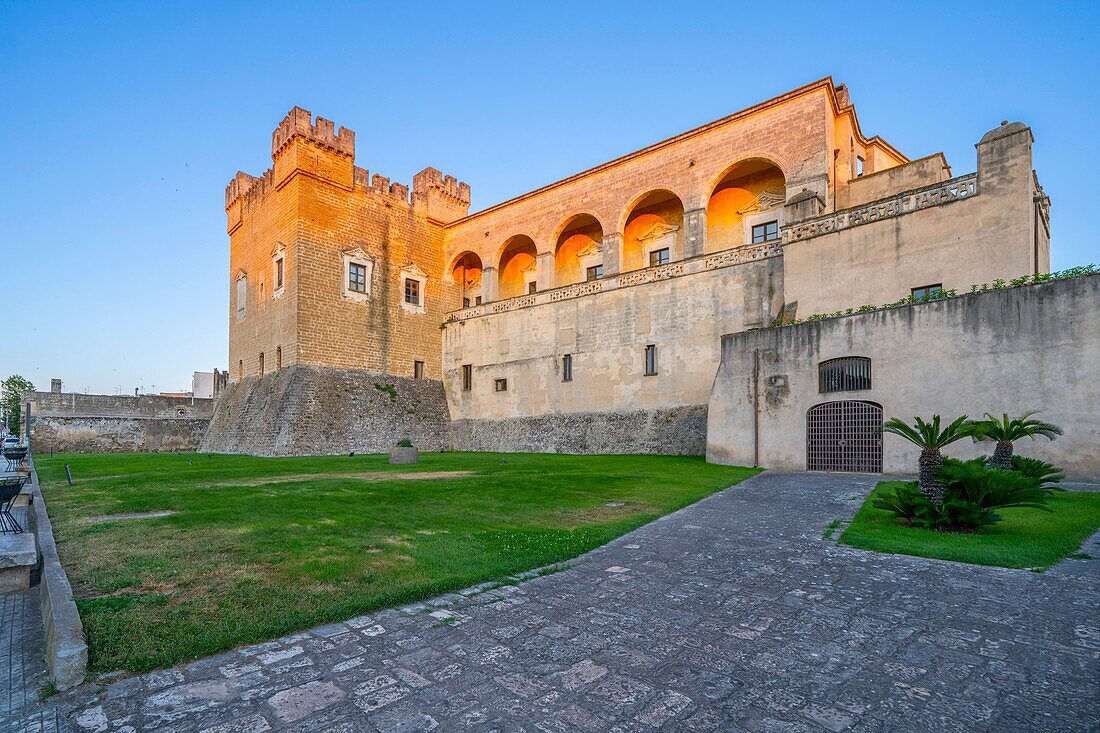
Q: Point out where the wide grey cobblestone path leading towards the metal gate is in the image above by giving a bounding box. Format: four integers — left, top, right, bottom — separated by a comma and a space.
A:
34, 472, 1100, 733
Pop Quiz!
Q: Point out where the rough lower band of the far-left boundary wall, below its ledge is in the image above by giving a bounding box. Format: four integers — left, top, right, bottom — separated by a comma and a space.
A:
31, 412, 210, 453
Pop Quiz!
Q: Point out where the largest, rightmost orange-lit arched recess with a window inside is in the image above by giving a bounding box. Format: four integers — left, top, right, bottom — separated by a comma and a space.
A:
706, 156, 787, 252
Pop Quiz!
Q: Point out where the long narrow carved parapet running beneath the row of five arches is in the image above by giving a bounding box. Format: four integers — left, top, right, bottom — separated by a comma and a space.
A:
447, 240, 783, 322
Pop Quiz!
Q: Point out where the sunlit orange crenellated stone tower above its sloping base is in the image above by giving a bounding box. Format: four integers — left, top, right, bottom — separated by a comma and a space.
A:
226, 107, 470, 381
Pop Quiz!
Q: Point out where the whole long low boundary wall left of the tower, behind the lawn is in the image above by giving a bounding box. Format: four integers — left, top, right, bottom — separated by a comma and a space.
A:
24, 392, 215, 453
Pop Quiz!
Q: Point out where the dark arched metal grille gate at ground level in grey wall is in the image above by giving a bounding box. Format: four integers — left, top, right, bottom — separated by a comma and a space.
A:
806, 400, 882, 473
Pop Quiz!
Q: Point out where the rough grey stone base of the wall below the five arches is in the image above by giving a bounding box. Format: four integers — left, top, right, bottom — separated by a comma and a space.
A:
451, 405, 706, 456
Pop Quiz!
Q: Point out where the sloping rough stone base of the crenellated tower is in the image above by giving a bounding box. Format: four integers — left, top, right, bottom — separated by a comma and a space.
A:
199, 364, 450, 456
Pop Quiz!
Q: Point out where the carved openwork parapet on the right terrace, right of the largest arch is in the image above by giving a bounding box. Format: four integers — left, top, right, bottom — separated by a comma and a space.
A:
783, 173, 979, 243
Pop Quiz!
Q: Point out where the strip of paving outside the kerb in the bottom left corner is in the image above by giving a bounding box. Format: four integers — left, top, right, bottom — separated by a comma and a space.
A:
0, 588, 58, 733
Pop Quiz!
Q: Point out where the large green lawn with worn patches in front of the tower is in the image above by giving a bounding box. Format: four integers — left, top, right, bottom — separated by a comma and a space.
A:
35, 453, 756, 671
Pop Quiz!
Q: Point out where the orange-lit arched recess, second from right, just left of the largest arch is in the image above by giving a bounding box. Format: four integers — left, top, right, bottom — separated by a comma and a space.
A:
619, 188, 684, 272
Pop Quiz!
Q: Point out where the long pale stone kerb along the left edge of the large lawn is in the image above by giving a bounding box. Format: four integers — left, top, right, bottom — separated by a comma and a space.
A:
28, 456, 88, 690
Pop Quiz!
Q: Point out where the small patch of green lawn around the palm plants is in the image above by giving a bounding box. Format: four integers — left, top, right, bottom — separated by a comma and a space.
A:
839, 481, 1100, 569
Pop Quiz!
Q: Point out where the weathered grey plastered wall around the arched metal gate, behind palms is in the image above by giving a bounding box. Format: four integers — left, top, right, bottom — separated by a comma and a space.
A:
706, 270, 1100, 480
